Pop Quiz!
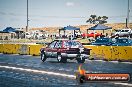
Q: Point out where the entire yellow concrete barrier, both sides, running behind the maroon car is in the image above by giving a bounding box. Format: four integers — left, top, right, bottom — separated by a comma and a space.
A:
0, 44, 132, 61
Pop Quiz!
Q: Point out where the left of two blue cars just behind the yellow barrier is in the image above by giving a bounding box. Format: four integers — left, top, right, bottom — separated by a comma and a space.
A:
91, 37, 113, 46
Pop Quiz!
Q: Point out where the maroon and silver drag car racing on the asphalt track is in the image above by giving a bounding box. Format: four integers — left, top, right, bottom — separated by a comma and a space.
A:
40, 40, 91, 63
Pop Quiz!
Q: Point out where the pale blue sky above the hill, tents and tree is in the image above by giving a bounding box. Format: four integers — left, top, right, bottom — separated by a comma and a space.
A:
0, 0, 132, 30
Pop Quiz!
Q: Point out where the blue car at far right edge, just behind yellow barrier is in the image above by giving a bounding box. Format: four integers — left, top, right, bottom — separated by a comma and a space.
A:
112, 38, 132, 46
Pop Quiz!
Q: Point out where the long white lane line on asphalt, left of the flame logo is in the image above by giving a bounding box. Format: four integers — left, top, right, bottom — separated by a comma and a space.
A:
0, 65, 76, 79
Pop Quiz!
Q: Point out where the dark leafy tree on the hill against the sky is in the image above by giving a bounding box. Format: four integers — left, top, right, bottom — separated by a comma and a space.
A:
86, 15, 108, 24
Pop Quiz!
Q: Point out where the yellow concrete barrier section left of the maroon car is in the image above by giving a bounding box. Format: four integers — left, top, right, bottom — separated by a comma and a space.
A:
0, 44, 43, 56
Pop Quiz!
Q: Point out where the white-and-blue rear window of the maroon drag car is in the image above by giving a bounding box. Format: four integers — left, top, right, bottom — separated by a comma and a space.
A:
64, 41, 83, 48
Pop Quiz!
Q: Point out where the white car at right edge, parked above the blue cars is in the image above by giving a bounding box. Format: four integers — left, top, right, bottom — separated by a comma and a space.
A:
112, 29, 132, 37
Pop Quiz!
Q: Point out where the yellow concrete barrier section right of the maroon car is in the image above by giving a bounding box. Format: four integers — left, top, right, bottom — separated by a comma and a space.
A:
85, 45, 132, 61
